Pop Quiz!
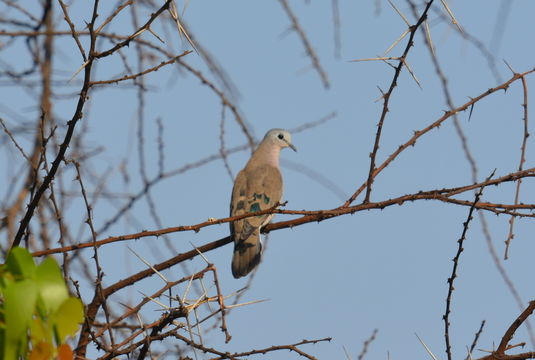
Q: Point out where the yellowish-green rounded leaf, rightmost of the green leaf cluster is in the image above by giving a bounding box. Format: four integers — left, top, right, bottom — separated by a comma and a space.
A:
50, 297, 84, 342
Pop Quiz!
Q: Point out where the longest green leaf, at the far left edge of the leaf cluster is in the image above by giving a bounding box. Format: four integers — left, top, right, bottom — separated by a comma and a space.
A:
3, 280, 37, 360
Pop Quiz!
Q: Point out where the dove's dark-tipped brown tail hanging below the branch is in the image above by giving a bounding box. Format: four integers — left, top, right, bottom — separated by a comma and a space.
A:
232, 228, 262, 279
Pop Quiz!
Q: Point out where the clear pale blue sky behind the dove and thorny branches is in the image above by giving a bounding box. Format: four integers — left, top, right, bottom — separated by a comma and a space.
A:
0, 0, 535, 359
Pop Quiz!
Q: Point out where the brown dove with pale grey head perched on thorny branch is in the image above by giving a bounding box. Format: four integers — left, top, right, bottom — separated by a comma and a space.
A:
230, 129, 297, 279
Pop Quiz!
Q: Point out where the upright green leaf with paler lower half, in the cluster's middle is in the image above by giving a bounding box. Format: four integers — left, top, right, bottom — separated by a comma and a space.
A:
35, 258, 69, 315
